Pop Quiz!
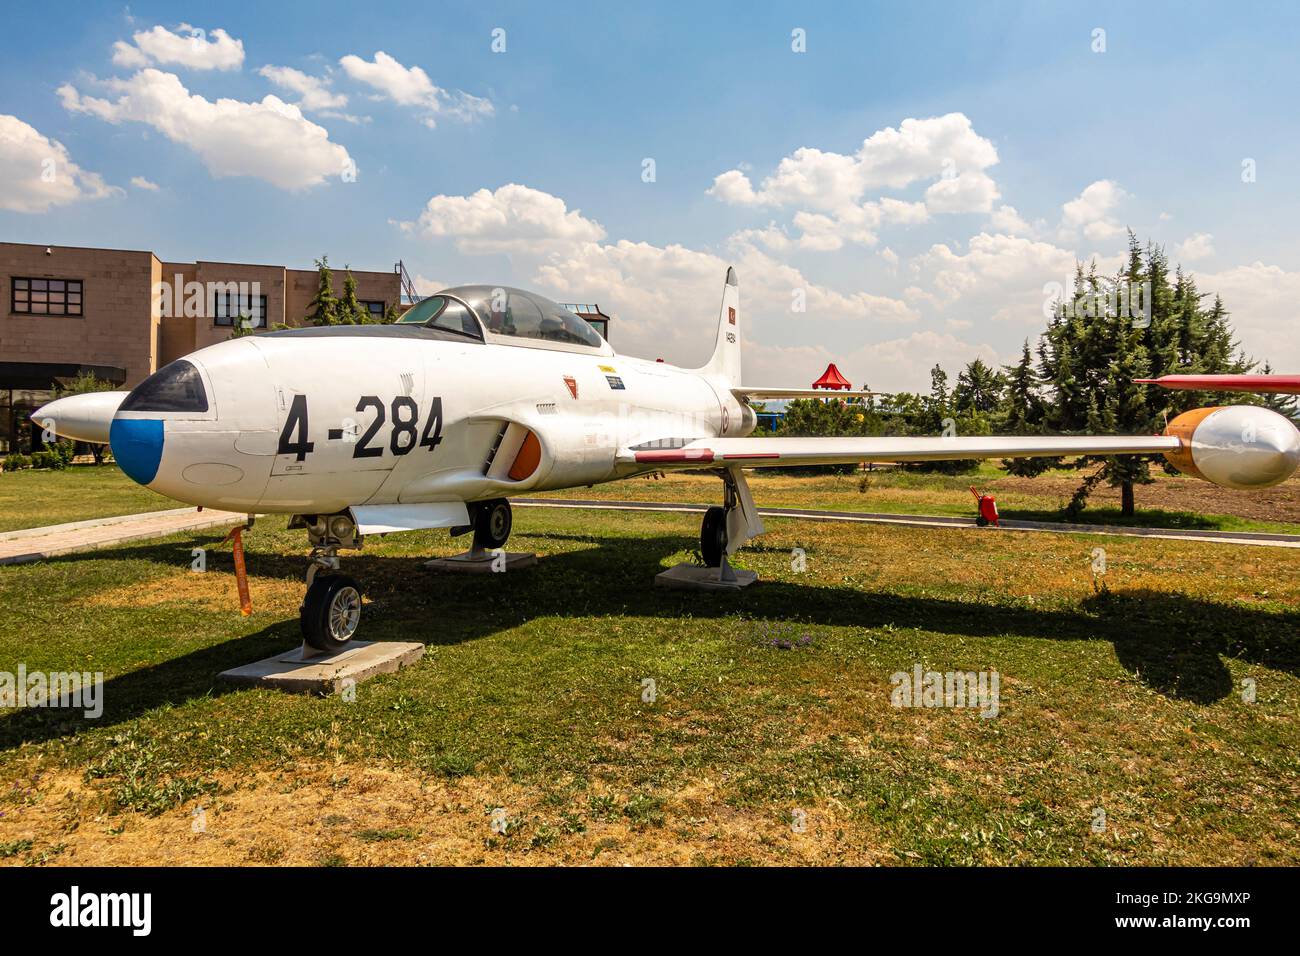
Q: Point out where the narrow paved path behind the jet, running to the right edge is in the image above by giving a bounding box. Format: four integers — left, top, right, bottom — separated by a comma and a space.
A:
510, 498, 1300, 548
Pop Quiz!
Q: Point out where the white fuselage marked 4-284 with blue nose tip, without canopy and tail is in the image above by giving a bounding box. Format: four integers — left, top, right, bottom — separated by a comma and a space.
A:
112, 326, 754, 514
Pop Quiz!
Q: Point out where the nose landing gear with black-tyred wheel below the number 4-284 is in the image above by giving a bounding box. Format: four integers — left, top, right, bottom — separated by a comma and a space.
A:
289, 514, 361, 654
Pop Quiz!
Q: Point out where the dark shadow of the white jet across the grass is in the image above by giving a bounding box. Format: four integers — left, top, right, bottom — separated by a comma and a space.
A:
0, 532, 1300, 749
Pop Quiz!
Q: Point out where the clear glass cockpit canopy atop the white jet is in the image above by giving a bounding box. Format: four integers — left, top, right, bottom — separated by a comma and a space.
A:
398, 285, 605, 350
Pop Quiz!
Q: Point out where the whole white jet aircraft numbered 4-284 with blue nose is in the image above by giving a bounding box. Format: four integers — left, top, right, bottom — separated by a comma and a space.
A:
33, 269, 1300, 650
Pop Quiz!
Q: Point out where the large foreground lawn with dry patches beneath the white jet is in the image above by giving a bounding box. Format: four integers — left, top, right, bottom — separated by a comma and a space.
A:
0, 509, 1300, 865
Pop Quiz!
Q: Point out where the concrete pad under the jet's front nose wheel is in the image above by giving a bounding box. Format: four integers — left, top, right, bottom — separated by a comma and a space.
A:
217, 641, 424, 695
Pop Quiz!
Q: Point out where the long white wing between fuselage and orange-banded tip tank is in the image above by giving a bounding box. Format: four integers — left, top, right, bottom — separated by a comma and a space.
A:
619, 434, 1180, 468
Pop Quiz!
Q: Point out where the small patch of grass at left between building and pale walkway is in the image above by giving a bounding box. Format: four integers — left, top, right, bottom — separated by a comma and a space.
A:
0, 463, 174, 531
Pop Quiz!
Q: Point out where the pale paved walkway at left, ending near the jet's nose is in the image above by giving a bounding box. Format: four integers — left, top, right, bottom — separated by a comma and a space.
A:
0, 507, 248, 564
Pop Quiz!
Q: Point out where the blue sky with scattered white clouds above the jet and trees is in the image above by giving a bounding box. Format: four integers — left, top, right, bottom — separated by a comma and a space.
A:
0, 3, 1300, 389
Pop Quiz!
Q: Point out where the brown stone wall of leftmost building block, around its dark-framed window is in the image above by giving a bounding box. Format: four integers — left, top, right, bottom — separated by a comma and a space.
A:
0, 242, 159, 388
